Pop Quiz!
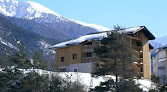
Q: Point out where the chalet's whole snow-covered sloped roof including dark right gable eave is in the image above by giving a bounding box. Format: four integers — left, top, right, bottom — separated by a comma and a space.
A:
51, 26, 155, 48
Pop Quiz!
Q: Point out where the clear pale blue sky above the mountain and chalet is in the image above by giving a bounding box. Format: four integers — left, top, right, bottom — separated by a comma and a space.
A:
19, 0, 167, 37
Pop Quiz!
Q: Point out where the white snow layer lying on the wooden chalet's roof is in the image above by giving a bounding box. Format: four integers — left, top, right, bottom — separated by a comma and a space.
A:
51, 26, 141, 48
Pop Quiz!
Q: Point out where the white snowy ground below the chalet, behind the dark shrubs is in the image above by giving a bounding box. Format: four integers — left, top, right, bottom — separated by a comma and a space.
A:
0, 68, 155, 91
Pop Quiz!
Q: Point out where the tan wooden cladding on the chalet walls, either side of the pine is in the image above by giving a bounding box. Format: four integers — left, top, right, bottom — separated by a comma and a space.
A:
56, 32, 151, 79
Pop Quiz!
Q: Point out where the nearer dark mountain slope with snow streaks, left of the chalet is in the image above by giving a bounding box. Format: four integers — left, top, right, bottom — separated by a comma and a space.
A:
0, 14, 57, 61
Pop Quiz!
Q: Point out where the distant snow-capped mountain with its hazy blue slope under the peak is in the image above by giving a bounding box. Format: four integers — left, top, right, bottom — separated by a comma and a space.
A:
0, 0, 110, 40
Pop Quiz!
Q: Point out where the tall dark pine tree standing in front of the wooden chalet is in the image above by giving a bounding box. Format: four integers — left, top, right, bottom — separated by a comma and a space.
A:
92, 27, 140, 92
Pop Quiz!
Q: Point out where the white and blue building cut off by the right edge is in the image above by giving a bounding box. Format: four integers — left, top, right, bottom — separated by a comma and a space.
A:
152, 46, 167, 85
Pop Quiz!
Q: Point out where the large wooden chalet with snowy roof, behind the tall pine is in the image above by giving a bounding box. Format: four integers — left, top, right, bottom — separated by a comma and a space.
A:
52, 26, 155, 79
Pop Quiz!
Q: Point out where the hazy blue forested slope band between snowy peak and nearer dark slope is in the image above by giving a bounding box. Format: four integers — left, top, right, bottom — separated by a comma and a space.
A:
0, 14, 71, 42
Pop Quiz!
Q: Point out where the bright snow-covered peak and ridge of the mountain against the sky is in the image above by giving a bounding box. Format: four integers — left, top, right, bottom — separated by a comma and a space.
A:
0, 0, 110, 31
